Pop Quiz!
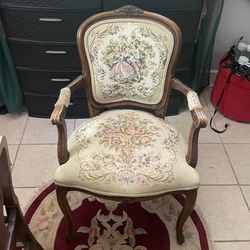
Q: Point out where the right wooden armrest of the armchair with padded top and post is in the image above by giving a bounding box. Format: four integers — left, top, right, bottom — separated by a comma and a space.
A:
172, 78, 207, 167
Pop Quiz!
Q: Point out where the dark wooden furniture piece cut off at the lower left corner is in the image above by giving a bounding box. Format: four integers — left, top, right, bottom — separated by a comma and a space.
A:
0, 136, 43, 250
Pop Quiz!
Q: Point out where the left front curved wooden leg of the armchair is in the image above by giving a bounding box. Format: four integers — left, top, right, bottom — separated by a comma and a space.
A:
56, 186, 74, 242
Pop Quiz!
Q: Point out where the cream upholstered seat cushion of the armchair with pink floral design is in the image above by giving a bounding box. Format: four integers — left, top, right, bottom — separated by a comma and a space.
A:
55, 110, 199, 197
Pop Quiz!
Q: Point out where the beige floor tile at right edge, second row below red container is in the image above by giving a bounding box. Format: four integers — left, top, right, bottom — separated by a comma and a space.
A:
225, 144, 250, 184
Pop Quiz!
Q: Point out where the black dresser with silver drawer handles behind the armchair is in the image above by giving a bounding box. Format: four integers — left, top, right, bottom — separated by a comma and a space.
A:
0, 0, 203, 118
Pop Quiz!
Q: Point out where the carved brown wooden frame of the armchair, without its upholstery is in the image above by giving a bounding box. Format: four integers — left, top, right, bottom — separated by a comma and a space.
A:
51, 5, 207, 244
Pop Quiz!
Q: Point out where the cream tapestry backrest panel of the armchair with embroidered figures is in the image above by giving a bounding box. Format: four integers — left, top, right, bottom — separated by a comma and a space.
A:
84, 18, 174, 104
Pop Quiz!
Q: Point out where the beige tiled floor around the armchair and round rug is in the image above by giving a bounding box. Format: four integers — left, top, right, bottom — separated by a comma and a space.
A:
0, 88, 250, 250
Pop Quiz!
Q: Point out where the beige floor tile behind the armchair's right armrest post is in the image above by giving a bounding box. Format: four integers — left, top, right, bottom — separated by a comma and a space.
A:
167, 110, 221, 143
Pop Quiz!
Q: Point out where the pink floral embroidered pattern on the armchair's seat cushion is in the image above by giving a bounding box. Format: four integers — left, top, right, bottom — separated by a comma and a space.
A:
75, 110, 180, 185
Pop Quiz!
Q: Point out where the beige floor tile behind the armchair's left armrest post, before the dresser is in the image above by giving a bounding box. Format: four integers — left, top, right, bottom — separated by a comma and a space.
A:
22, 117, 75, 144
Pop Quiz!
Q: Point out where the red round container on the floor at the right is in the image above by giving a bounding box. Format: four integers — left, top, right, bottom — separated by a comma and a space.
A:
211, 60, 250, 122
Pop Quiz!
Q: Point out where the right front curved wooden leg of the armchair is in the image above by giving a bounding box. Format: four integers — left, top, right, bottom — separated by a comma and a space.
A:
176, 189, 198, 244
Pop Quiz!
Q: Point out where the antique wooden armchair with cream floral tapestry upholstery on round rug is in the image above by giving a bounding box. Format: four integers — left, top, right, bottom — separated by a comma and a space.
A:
51, 6, 207, 244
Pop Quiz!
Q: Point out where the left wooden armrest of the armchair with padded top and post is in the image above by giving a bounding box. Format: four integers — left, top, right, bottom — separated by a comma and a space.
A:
50, 75, 84, 165
